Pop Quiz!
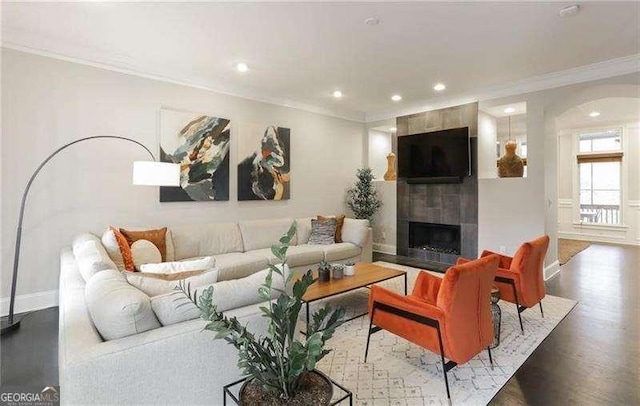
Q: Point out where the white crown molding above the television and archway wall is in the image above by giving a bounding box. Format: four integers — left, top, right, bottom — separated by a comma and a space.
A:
365, 54, 640, 123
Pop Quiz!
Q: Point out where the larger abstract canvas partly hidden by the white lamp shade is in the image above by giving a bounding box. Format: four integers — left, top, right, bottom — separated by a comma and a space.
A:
160, 109, 231, 202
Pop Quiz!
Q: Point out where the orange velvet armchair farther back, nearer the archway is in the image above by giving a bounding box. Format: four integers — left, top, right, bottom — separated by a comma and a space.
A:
480, 235, 549, 334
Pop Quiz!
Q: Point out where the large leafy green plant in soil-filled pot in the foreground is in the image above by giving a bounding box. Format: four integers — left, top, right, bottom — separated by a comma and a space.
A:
177, 222, 344, 405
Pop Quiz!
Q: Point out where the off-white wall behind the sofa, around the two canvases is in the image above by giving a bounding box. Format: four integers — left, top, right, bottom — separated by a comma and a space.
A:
1, 50, 365, 307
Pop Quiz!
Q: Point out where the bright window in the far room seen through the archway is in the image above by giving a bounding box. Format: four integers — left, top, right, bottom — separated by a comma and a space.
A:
578, 128, 622, 225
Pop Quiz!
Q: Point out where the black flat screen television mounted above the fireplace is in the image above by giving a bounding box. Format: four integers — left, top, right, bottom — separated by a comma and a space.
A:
398, 127, 471, 181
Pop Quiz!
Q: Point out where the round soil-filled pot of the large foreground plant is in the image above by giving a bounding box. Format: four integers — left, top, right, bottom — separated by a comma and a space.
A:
239, 370, 333, 406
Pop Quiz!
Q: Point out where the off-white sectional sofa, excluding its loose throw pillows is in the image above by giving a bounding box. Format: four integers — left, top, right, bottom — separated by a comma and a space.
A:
59, 218, 372, 405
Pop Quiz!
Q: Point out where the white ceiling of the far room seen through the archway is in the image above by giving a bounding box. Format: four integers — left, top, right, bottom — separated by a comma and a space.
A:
556, 97, 640, 129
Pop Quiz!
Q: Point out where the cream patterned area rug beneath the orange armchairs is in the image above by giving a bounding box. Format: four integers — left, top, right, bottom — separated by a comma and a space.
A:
312, 262, 577, 405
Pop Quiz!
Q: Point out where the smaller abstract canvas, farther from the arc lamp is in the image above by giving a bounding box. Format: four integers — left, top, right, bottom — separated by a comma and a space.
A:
238, 125, 291, 200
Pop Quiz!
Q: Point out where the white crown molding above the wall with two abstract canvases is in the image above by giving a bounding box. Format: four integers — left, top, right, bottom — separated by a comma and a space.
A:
0, 41, 365, 123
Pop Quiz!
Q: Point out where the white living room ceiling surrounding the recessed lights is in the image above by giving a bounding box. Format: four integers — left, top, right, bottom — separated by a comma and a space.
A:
2, 2, 640, 119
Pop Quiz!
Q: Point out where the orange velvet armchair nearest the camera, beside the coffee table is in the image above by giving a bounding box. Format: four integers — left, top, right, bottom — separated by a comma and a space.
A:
364, 255, 500, 398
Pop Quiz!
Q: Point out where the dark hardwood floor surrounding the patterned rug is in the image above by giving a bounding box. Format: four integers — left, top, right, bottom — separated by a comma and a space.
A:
0, 244, 640, 405
